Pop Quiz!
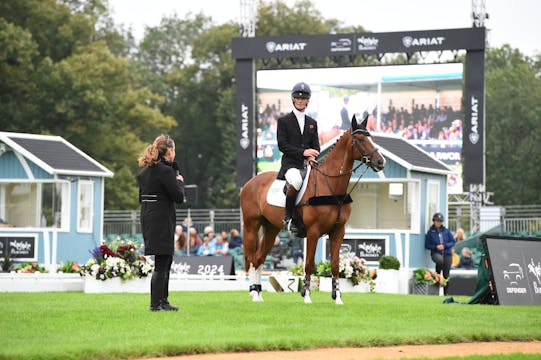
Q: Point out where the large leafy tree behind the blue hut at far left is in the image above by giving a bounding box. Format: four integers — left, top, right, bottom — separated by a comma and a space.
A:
0, 0, 176, 209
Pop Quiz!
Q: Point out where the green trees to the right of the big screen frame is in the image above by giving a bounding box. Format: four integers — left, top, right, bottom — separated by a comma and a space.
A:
485, 45, 541, 205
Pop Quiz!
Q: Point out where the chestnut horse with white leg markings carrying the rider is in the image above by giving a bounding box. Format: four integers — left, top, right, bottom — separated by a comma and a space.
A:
240, 116, 385, 304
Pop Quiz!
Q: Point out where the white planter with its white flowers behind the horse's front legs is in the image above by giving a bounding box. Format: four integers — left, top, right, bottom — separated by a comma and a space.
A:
316, 253, 378, 292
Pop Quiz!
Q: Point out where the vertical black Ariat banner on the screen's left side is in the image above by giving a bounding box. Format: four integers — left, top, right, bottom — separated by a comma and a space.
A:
235, 59, 255, 186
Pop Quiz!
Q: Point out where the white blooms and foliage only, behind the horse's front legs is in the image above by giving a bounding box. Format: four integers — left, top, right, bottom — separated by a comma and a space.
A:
316, 253, 378, 292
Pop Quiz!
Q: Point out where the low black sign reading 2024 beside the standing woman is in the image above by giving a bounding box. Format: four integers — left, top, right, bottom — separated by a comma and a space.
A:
171, 256, 235, 276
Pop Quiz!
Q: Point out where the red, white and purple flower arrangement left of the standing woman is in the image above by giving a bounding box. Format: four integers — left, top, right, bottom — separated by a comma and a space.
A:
80, 242, 154, 281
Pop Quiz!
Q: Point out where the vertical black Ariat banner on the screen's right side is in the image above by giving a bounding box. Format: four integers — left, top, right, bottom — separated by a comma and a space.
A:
462, 51, 485, 186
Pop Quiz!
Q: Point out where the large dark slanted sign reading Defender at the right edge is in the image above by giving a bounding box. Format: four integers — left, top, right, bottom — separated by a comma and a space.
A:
481, 236, 541, 305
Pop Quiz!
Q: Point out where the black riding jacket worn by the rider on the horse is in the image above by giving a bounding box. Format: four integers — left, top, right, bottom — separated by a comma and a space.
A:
277, 111, 319, 180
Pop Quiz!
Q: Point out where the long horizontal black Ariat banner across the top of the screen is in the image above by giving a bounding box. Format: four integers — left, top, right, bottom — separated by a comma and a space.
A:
232, 28, 485, 59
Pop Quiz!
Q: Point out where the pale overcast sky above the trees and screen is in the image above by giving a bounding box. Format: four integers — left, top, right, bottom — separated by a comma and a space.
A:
109, 0, 541, 56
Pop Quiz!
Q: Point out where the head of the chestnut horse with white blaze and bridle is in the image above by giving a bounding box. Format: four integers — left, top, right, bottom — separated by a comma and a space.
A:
351, 115, 385, 171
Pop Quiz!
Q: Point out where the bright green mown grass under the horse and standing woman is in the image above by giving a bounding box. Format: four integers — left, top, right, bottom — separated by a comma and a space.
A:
0, 291, 541, 359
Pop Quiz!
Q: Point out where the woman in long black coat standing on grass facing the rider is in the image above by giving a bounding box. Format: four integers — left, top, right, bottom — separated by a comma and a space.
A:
137, 135, 184, 311
